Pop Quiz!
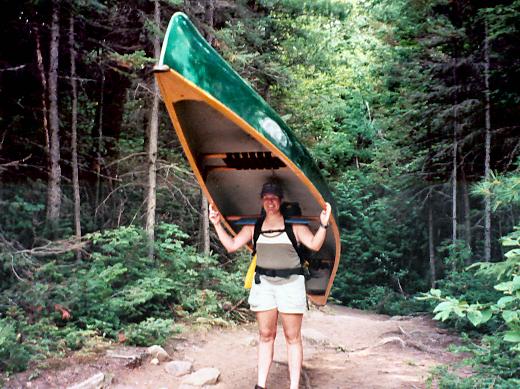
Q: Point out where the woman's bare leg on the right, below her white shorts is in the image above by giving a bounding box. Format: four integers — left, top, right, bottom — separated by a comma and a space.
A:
280, 313, 303, 389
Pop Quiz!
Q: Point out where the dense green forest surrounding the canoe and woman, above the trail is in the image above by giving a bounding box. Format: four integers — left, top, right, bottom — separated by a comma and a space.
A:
0, 0, 520, 387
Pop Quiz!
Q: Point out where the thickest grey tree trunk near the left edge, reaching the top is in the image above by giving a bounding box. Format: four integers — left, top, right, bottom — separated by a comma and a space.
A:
47, 0, 61, 230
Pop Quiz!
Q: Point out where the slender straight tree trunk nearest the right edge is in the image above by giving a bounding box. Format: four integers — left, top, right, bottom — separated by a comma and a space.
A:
484, 21, 491, 262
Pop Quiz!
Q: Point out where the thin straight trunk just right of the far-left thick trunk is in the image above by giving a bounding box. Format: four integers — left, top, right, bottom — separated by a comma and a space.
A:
69, 13, 81, 261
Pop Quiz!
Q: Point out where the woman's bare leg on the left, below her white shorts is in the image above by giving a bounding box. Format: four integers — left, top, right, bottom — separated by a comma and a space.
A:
256, 308, 278, 388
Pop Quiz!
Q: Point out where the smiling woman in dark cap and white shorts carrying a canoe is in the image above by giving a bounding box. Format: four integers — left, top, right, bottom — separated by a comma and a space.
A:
209, 182, 331, 389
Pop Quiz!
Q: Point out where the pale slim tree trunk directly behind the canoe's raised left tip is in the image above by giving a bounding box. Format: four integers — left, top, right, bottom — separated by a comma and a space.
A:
146, 0, 161, 259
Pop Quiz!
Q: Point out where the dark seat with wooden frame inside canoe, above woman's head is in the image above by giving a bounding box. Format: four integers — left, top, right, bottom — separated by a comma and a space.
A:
200, 151, 286, 175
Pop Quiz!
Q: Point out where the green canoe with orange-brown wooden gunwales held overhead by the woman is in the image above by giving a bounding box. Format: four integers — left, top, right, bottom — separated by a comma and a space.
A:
155, 13, 340, 305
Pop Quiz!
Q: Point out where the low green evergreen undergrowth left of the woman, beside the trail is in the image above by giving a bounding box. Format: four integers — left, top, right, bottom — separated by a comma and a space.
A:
0, 223, 245, 370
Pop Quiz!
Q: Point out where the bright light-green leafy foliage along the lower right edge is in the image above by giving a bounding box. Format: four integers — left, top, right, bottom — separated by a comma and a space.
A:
420, 172, 520, 382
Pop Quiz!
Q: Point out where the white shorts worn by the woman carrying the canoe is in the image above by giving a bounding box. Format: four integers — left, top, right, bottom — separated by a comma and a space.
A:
248, 275, 307, 313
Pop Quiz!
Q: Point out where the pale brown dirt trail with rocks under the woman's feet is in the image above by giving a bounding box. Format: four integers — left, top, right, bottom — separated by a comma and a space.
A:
8, 305, 464, 389
